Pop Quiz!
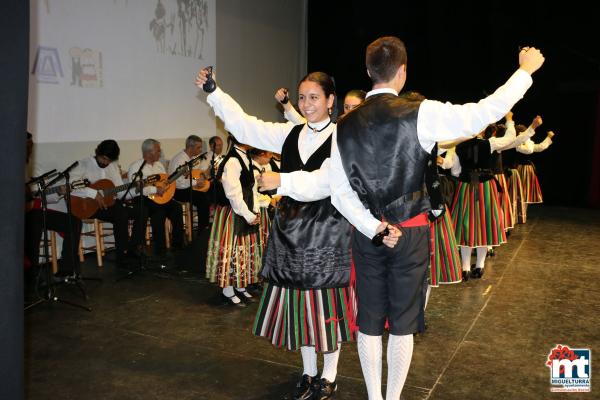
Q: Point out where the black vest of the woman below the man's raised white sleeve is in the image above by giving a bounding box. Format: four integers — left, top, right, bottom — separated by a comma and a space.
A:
456, 138, 494, 183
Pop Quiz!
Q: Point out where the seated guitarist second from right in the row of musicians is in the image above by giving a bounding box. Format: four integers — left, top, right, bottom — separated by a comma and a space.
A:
169, 135, 210, 234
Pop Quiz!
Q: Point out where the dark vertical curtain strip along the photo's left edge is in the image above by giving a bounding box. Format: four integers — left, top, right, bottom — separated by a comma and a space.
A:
0, 0, 29, 400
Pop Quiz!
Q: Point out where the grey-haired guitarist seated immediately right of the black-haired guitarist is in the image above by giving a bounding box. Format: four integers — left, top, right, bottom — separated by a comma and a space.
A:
127, 139, 183, 257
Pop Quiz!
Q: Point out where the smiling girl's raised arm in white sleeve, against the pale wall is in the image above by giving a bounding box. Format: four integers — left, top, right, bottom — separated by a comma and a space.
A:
196, 69, 294, 153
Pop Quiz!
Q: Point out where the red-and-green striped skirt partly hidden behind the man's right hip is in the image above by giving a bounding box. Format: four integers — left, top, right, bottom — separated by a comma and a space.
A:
429, 207, 462, 287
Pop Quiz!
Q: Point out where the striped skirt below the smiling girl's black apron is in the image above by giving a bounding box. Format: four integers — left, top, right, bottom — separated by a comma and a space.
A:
252, 283, 354, 353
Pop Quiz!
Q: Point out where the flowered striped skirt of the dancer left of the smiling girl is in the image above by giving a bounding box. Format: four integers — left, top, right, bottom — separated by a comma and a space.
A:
206, 206, 266, 288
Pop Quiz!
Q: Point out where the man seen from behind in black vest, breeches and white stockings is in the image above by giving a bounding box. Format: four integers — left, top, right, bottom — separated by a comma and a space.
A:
330, 37, 544, 400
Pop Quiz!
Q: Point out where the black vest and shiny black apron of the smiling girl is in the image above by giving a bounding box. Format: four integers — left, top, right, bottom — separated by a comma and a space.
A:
262, 125, 352, 289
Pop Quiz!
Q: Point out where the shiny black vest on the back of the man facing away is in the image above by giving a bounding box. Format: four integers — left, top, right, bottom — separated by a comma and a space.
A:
337, 93, 431, 224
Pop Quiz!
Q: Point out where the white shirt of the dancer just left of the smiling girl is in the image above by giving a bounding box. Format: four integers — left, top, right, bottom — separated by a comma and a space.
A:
221, 147, 259, 223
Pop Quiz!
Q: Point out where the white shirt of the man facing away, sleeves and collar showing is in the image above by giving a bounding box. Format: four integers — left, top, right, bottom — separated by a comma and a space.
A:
329, 69, 532, 238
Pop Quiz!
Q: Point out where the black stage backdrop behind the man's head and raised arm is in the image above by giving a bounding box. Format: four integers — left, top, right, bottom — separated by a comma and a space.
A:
308, 0, 600, 207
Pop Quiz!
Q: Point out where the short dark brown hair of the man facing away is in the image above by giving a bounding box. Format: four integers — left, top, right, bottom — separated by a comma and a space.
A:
365, 36, 407, 83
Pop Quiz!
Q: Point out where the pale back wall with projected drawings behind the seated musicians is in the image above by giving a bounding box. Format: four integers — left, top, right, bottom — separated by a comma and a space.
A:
29, 0, 306, 175
